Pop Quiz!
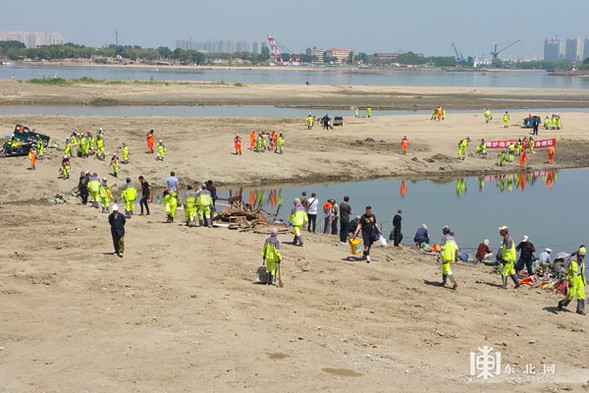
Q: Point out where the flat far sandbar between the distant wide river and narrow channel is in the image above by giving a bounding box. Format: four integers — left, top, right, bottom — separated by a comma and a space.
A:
0, 80, 589, 108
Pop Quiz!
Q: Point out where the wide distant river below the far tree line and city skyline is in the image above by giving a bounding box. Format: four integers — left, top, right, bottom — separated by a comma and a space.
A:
0, 65, 589, 89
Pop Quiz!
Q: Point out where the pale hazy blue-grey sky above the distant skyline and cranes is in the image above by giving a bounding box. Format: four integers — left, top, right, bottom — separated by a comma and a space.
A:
0, 0, 589, 58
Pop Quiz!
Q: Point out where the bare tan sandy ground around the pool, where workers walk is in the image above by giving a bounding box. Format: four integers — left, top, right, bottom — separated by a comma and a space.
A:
0, 84, 589, 392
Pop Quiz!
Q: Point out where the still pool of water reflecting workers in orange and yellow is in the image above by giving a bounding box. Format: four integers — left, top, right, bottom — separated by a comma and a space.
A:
212, 169, 589, 255
